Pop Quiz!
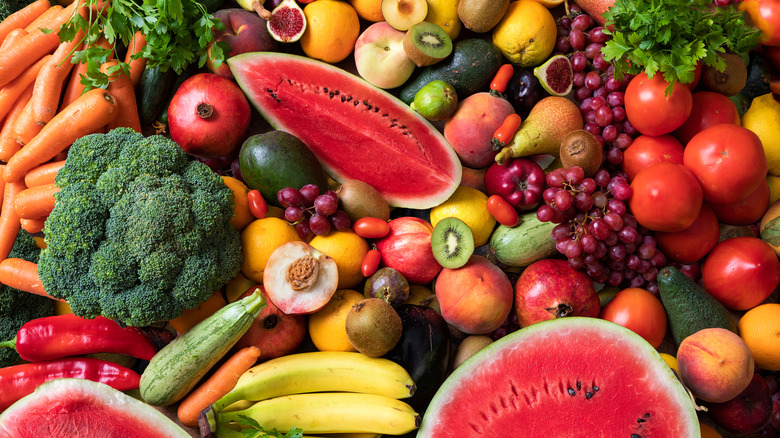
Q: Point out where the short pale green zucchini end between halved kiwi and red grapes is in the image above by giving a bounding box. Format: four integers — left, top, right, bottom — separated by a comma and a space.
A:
489, 211, 557, 268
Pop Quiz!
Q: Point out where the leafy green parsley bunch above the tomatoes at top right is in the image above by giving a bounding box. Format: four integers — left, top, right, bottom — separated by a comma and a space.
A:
601, 0, 761, 94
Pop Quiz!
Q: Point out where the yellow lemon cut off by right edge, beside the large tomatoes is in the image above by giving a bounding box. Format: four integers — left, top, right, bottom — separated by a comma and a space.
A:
742, 93, 780, 175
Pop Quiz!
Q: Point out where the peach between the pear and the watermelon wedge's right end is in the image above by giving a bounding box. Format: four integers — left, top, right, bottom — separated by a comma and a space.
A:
444, 92, 515, 169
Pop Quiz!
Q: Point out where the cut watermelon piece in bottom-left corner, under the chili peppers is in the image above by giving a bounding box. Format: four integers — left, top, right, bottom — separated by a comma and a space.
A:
0, 379, 190, 438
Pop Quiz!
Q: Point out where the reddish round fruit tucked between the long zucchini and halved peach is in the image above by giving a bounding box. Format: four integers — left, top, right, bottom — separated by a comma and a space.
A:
233, 285, 307, 361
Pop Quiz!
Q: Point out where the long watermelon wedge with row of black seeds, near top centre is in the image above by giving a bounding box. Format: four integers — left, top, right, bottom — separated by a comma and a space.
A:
228, 52, 462, 209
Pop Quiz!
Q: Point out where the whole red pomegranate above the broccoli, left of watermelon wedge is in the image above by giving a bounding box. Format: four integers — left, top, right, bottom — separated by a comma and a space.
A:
168, 73, 252, 158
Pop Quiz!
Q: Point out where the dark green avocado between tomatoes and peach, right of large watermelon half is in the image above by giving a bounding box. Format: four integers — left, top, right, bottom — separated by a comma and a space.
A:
656, 266, 737, 346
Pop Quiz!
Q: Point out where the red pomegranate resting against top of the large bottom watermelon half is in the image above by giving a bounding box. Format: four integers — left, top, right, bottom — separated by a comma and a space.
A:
515, 259, 601, 327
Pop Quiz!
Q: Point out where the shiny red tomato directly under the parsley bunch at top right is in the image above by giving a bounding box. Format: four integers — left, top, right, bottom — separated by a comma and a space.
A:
625, 72, 693, 135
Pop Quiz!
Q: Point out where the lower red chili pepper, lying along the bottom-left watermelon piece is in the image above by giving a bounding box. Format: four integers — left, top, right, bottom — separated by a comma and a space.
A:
0, 357, 141, 412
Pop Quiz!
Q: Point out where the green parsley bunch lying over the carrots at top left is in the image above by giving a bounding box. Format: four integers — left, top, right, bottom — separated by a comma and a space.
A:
59, 0, 228, 88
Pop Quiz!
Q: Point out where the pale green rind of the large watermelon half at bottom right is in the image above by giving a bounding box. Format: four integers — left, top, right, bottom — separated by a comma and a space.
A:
417, 316, 701, 438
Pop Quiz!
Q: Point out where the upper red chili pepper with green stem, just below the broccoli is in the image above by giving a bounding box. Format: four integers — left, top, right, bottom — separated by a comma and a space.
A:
0, 313, 157, 362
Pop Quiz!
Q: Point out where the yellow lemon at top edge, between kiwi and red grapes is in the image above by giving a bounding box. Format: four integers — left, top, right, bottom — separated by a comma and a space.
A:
493, 0, 557, 67
